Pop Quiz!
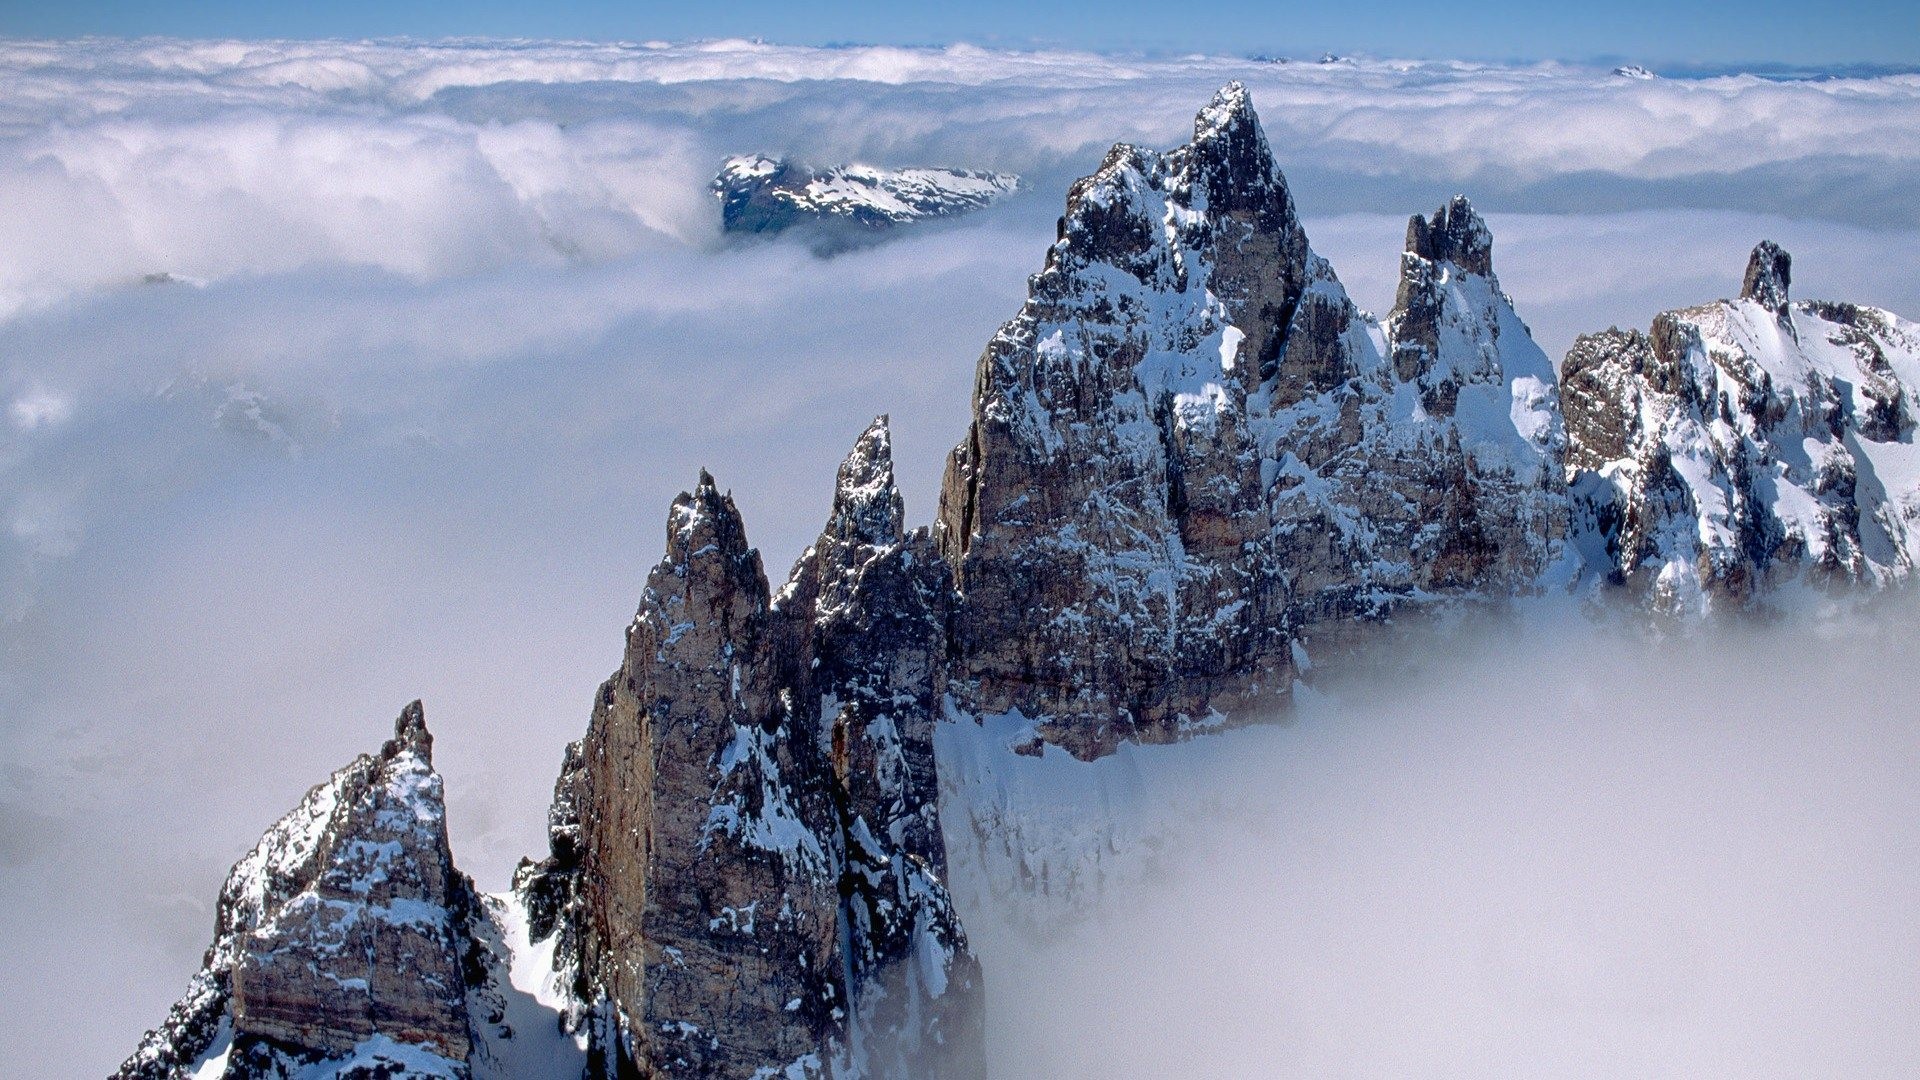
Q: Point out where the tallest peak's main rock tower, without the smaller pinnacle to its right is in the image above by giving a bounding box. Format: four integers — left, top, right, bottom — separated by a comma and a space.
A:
939, 86, 1313, 755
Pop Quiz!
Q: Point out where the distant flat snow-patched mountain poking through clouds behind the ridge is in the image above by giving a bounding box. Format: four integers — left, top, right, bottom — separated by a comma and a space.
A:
712, 154, 1020, 246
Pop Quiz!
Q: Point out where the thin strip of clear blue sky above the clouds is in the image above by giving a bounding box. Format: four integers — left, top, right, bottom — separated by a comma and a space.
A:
0, 0, 1920, 67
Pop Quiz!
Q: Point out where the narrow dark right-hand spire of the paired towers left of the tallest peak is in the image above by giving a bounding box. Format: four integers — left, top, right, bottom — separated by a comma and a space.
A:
776, 417, 985, 1080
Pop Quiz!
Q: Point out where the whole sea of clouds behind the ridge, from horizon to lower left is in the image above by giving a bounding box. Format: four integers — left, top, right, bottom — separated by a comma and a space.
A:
0, 40, 1920, 1076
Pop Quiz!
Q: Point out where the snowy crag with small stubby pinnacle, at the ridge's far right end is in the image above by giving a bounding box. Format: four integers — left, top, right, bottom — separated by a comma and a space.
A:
1561, 242, 1920, 613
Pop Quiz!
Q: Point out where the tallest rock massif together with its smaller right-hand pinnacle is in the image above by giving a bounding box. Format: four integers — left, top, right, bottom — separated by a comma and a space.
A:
939, 85, 1567, 757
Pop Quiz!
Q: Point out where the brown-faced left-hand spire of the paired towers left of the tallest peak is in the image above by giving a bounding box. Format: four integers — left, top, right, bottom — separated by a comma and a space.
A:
549, 475, 845, 1076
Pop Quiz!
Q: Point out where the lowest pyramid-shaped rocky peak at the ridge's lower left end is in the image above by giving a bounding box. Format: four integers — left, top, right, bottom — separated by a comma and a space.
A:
119, 701, 488, 1080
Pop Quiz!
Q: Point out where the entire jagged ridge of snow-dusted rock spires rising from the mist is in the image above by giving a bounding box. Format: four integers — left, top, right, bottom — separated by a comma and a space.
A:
123, 85, 1920, 1080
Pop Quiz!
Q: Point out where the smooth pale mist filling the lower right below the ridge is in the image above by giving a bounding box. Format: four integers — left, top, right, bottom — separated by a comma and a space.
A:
948, 611, 1920, 1080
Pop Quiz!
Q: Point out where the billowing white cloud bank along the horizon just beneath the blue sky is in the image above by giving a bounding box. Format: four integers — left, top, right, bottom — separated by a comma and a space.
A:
0, 42, 1920, 311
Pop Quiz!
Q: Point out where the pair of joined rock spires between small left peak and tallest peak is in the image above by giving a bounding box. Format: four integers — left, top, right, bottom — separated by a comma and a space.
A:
518, 421, 981, 1078
